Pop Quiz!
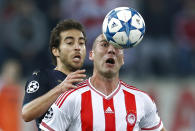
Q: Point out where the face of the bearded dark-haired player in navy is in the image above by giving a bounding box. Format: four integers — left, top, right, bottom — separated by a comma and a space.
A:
59, 29, 86, 70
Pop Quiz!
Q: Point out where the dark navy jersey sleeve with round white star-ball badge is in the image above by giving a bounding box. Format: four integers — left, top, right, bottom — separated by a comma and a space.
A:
23, 71, 48, 105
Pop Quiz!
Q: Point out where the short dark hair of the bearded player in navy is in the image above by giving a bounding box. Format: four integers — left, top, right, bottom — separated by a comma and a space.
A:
49, 19, 86, 65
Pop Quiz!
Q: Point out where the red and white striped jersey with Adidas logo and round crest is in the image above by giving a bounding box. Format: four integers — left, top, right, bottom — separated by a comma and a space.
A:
40, 78, 163, 131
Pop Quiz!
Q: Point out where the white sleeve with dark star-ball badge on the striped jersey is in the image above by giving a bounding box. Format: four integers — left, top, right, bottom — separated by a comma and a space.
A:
39, 93, 77, 131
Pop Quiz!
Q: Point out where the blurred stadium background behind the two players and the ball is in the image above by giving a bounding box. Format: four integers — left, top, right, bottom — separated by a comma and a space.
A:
0, 0, 195, 131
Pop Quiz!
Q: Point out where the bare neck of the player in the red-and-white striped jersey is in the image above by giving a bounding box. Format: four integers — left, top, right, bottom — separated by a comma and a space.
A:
90, 74, 119, 96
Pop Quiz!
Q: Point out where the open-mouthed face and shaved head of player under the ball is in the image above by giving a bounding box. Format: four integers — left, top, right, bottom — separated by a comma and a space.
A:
90, 35, 124, 77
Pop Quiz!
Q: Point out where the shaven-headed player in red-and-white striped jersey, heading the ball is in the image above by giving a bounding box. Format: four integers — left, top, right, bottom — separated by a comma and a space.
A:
40, 35, 165, 131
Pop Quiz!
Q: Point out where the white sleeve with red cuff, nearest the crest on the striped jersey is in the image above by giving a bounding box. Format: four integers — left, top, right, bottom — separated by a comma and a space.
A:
140, 96, 163, 131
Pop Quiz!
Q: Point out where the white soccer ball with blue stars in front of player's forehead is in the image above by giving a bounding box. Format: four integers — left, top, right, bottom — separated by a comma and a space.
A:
102, 7, 145, 48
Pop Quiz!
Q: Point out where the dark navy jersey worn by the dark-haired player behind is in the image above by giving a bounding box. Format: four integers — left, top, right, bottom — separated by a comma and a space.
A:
23, 69, 66, 129
